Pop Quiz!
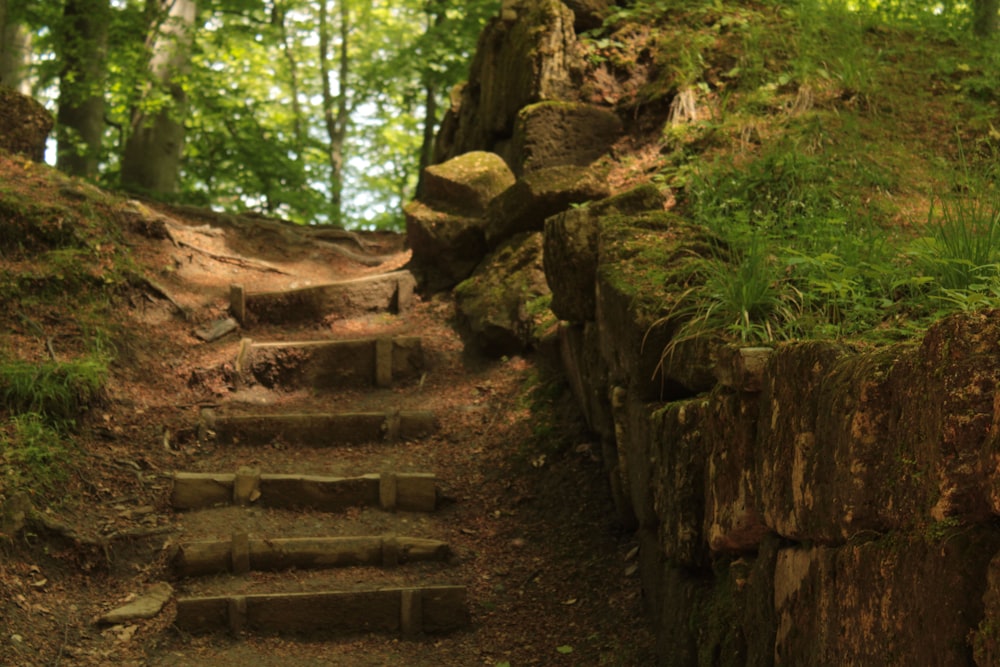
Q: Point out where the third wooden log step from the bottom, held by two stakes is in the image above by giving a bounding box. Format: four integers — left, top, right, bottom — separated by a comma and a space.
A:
170, 468, 438, 512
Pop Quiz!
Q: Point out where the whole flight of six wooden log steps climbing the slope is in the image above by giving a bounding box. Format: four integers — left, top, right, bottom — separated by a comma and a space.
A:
159, 271, 470, 638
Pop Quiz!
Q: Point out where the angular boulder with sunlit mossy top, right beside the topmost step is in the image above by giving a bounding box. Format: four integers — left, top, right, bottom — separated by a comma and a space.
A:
404, 152, 514, 292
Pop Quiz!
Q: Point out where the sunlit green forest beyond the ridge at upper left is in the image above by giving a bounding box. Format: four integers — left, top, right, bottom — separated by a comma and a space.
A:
0, 0, 498, 228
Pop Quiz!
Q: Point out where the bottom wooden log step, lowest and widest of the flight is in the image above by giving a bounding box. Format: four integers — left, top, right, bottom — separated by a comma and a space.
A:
174, 586, 469, 636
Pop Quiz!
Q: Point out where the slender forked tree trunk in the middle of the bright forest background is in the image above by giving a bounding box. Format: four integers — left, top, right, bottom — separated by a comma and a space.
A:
319, 0, 351, 225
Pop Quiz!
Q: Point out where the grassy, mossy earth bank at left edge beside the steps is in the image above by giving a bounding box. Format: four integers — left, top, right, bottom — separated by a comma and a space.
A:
0, 154, 127, 508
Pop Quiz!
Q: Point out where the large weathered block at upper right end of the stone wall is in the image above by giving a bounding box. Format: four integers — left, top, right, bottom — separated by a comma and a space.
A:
756, 313, 1000, 543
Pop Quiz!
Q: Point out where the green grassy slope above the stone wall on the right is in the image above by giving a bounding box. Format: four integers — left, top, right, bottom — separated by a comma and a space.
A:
584, 0, 1000, 345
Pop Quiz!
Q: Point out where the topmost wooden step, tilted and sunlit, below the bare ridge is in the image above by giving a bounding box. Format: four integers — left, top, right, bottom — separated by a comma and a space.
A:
229, 271, 417, 326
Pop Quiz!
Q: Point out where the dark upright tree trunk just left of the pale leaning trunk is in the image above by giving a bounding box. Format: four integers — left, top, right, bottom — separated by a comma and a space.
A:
56, 0, 111, 178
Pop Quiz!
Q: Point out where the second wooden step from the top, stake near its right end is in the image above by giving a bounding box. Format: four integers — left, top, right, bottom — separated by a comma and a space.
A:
236, 336, 425, 389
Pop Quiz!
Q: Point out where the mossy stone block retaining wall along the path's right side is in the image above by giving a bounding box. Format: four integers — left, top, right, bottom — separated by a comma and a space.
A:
546, 207, 1000, 666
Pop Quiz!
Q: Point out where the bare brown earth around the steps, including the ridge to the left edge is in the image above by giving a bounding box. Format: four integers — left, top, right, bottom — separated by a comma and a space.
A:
0, 156, 654, 667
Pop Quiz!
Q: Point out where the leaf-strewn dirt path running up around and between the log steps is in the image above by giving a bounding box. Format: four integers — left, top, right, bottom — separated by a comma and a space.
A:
0, 206, 652, 667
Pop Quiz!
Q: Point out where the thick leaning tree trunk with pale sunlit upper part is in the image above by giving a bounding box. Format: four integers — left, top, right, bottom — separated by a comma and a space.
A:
122, 0, 197, 194
